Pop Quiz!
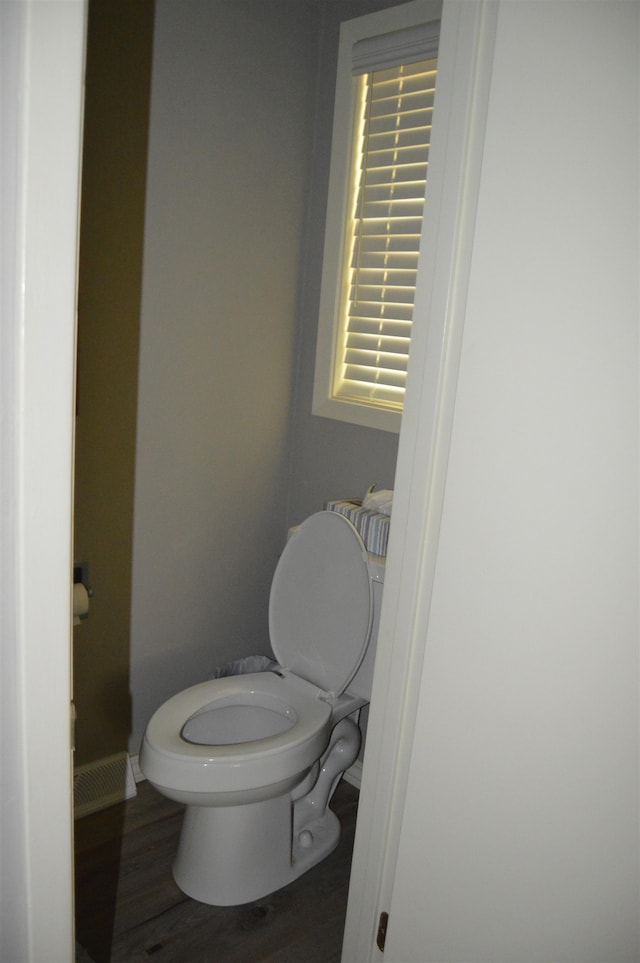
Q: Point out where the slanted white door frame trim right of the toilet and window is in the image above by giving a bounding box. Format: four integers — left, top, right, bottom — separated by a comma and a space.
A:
342, 0, 499, 963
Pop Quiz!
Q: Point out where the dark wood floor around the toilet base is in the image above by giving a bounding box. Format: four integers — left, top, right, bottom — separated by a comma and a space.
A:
75, 780, 358, 963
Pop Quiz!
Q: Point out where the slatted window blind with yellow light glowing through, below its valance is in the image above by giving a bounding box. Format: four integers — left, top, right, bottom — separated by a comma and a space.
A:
334, 58, 437, 409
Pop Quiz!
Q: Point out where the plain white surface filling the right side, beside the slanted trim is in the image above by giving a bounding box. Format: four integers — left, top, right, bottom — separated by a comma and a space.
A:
385, 2, 640, 963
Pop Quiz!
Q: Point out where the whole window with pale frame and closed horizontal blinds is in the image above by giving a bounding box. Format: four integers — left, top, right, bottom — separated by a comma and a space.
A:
313, 3, 439, 431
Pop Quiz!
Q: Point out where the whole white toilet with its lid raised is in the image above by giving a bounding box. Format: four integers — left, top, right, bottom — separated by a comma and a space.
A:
140, 511, 384, 906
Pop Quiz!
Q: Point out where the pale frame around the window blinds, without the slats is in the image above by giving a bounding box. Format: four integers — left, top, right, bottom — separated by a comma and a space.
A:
312, 0, 441, 433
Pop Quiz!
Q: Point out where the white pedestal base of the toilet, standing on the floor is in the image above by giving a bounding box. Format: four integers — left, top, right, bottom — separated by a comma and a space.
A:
173, 794, 340, 906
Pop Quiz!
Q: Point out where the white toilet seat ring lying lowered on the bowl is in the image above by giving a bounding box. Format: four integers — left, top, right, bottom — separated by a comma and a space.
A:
141, 672, 331, 793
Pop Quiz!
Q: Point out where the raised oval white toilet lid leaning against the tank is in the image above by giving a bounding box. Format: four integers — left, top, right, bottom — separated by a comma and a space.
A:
269, 512, 373, 696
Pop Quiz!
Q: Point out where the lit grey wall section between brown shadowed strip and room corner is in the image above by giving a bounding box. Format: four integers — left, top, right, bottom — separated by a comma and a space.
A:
131, 0, 320, 752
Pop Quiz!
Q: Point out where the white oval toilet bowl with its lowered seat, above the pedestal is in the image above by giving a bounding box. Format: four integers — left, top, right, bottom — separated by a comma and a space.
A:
141, 672, 331, 806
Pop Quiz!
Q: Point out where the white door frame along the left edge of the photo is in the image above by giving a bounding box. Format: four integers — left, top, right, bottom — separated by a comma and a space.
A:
0, 0, 87, 963
